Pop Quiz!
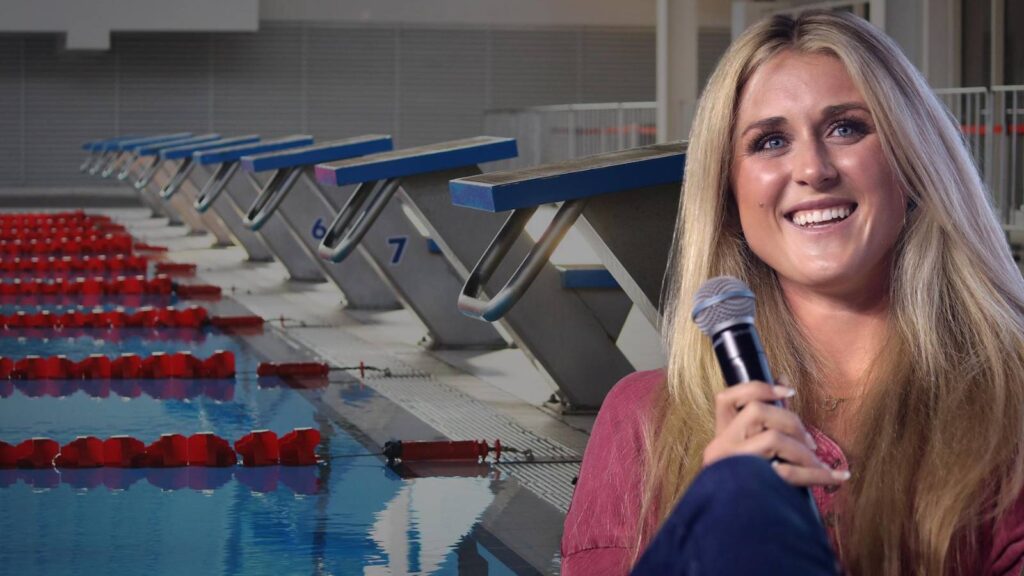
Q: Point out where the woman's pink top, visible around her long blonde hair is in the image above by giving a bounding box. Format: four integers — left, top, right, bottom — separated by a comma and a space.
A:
562, 370, 1024, 576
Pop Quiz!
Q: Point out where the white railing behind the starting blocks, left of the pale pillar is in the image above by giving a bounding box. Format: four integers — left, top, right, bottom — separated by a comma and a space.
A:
483, 102, 657, 170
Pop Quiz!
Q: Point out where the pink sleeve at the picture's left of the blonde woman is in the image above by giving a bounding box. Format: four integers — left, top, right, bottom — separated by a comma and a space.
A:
561, 370, 665, 576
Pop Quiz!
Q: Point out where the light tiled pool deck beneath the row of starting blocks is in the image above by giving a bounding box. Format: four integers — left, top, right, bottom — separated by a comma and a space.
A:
99, 207, 594, 573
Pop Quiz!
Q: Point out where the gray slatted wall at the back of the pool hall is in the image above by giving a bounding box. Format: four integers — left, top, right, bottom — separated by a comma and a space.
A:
0, 23, 655, 188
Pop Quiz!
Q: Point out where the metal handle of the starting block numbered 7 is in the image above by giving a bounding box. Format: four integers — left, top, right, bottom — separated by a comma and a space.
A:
316, 178, 400, 262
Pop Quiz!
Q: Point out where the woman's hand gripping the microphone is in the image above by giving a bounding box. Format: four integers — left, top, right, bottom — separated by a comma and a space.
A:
703, 381, 849, 486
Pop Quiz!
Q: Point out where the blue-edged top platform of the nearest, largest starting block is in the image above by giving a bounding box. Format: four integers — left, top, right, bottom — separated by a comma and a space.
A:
449, 142, 686, 212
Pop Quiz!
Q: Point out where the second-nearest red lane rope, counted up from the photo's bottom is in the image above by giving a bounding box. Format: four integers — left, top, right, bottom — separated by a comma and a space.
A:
0, 351, 234, 380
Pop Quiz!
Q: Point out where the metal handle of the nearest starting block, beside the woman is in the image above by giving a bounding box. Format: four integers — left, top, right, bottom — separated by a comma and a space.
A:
458, 199, 587, 322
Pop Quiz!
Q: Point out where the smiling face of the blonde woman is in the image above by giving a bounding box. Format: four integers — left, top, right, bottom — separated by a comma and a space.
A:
730, 51, 906, 297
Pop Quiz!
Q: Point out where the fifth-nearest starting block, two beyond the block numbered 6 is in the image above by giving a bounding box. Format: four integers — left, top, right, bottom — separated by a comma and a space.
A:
152, 134, 273, 262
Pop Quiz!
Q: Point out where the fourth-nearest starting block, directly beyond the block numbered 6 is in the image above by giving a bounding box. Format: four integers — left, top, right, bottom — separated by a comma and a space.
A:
191, 135, 350, 282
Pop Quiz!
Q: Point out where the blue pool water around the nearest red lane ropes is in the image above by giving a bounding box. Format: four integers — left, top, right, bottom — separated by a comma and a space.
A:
0, 323, 529, 576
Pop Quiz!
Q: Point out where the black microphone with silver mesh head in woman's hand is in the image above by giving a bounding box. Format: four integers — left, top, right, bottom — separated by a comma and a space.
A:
690, 276, 821, 523
